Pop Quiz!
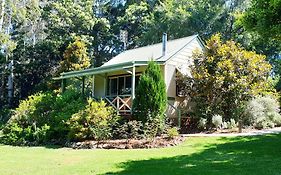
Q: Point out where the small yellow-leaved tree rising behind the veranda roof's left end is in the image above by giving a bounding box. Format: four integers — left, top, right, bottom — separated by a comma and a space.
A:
60, 37, 90, 72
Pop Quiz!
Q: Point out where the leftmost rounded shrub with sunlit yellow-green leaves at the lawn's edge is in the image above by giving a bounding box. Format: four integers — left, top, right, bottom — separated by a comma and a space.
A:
0, 93, 53, 145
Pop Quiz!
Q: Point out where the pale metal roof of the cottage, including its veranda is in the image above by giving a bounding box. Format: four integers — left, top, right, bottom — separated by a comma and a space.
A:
53, 35, 203, 80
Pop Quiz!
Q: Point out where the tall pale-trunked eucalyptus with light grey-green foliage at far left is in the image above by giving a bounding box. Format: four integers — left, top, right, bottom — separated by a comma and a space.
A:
0, 0, 44, 106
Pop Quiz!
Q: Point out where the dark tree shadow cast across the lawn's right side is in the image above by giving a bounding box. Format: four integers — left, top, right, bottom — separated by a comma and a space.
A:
101, 135, 281, 175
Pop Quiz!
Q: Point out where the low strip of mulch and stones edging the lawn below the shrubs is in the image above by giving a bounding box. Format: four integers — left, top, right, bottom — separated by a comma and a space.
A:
66, 136, 185, 149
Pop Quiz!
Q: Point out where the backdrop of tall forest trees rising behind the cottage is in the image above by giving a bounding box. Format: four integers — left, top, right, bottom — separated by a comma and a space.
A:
0, 0, 281, 106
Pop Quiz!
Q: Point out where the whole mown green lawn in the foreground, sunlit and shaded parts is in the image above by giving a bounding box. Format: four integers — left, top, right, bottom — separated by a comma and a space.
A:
0, 135, 281, 175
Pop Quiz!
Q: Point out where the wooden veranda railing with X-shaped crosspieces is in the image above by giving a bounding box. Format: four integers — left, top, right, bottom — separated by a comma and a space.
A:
103, 95, 132, 114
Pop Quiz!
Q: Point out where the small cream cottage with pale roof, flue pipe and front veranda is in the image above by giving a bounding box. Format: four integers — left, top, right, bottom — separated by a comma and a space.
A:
55, 34, 204, 122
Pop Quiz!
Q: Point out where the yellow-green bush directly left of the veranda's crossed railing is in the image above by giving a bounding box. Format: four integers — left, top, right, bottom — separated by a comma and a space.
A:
68, 99, 118, 141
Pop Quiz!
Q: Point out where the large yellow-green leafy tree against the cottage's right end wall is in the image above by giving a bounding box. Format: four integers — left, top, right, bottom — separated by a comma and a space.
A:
177, 35, 274, 122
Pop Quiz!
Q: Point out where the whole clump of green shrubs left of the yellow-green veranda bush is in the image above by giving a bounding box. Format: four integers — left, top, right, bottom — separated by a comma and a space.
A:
3, 90, 85, 145
